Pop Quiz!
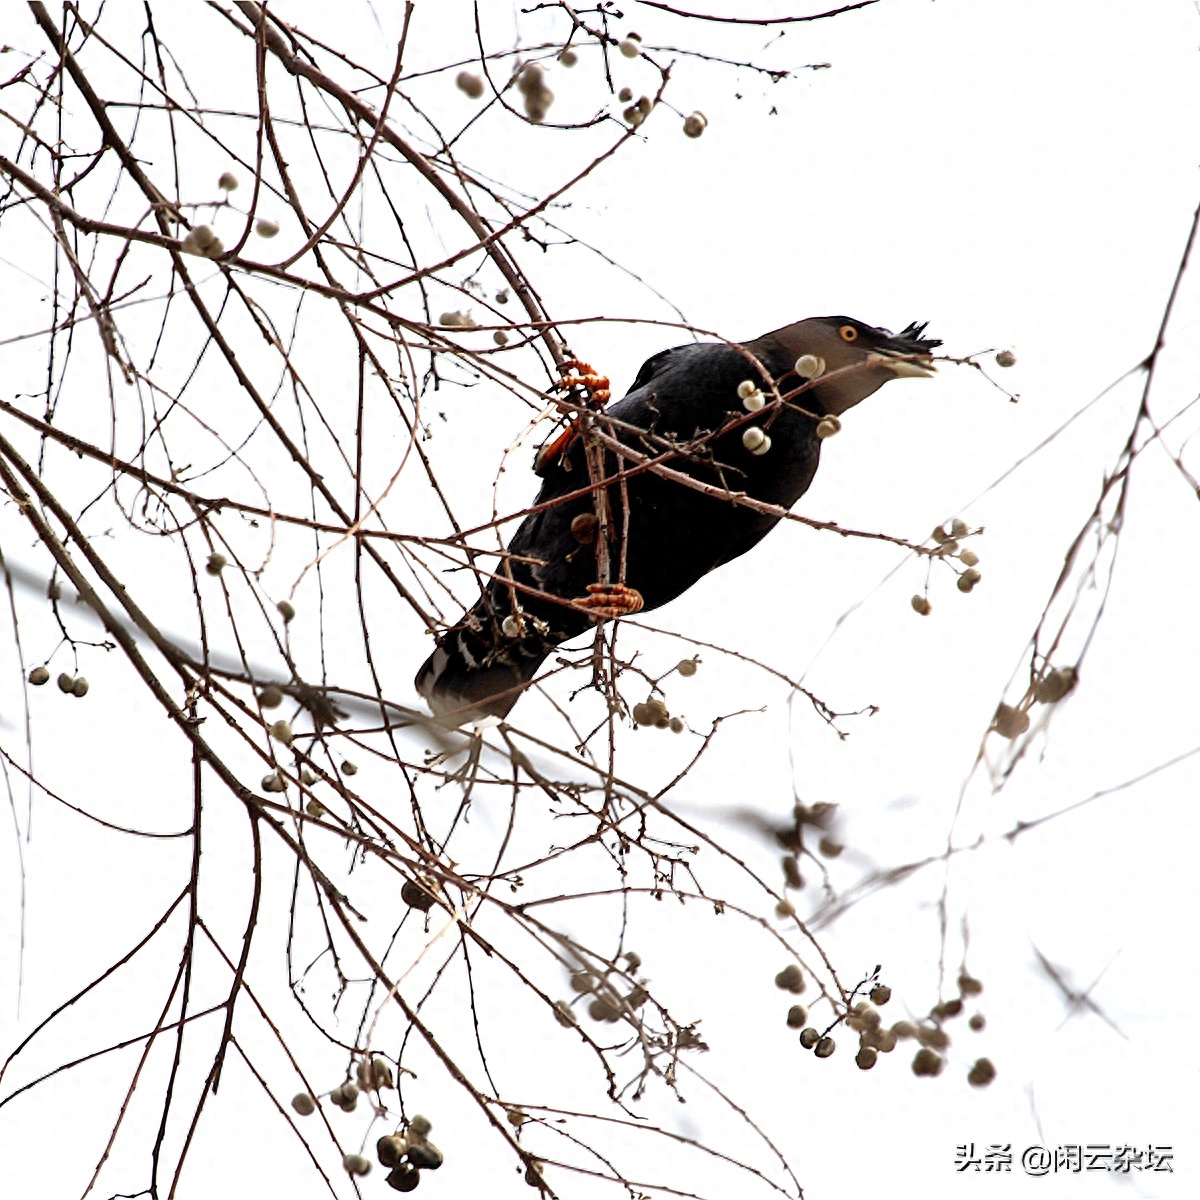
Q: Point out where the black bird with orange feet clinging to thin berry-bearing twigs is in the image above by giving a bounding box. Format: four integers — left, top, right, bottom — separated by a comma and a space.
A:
416, 317, 942, 724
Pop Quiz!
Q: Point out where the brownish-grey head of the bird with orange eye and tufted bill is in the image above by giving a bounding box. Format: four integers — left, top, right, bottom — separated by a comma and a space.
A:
748, 317, 942, 416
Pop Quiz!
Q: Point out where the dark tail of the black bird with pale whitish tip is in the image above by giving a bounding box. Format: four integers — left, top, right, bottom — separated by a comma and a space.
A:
415, 613, 552, 725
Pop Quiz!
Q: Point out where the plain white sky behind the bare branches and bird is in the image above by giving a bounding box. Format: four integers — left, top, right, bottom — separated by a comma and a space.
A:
0, 0, 1200, 1200
